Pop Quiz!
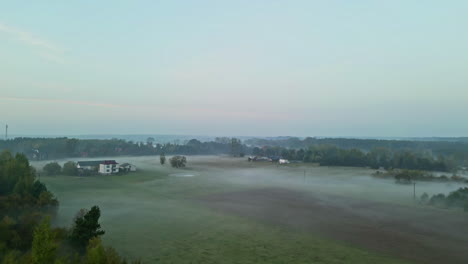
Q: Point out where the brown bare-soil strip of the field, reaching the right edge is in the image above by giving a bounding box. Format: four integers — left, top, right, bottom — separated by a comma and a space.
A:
201, 188, 468, 264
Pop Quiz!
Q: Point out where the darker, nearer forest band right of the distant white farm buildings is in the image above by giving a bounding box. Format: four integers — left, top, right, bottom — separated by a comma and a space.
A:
252, 145, 455, 171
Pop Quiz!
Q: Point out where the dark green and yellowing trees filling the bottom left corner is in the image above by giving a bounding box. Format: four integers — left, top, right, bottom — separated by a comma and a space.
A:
0, 151, 137, 264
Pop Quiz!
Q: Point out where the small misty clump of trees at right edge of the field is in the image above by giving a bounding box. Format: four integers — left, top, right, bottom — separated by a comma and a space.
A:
420, 187, 468, 212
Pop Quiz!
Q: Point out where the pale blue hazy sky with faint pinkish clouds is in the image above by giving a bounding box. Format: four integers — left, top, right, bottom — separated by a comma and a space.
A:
0, 0, 468, 137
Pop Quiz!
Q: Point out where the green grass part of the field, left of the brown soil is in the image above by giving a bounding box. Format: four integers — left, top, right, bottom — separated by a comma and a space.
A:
34, 157, 416, 264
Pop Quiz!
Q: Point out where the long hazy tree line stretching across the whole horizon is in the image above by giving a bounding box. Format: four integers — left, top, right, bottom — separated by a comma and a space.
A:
0, 138, 460, 171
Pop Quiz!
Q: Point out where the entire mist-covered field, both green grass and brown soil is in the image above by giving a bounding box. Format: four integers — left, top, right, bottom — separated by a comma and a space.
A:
33, 156, 468, 263
